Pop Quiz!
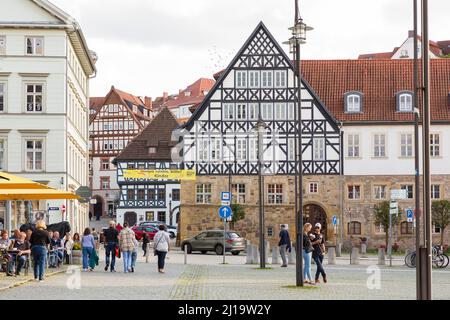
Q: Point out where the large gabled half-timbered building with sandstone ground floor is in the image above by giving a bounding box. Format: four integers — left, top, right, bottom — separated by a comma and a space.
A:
180, 23, 342, 242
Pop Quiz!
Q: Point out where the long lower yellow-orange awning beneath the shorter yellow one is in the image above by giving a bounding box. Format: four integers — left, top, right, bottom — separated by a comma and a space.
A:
0, 188, 80, 200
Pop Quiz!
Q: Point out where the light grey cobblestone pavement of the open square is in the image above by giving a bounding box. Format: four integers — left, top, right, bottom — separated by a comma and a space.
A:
0, 252, 450, 300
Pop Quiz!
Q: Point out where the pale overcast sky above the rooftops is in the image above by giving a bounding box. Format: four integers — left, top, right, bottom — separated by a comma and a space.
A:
51, 0, 450, 97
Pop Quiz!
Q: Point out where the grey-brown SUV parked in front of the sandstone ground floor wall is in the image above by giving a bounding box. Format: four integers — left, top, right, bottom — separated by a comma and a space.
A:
181, 230, 245, 256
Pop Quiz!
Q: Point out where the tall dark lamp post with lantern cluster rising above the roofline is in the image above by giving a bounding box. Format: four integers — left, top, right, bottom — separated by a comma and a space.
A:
284, 0, 313, 287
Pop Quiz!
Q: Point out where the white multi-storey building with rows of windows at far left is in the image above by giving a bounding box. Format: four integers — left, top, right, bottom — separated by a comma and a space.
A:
0, 0, 96, 231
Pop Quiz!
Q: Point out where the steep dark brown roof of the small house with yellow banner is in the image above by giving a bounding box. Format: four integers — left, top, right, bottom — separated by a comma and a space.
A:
114, 108, 179, 162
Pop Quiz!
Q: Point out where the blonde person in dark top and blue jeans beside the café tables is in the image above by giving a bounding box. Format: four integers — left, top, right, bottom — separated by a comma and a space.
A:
30, 220, 50, 282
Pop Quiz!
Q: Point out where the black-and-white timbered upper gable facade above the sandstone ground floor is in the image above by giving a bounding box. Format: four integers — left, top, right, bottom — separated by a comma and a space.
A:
183, 22, 342, 176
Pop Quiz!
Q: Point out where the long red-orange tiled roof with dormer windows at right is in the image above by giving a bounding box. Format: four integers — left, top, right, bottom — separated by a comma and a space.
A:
302, 59, 450, 122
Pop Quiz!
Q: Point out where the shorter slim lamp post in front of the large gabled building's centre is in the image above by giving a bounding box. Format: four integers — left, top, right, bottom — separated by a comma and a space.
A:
254, 113, 267, 269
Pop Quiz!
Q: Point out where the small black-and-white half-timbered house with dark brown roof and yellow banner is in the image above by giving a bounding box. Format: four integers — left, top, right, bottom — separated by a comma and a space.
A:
113, 108, 181, 225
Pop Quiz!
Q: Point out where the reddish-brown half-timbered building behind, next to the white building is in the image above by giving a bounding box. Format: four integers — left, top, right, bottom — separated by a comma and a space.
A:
89, 87, 153, 216
